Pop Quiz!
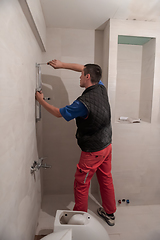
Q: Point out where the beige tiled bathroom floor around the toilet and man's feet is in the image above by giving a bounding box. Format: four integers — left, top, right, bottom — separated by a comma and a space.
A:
36, 195, 160, 240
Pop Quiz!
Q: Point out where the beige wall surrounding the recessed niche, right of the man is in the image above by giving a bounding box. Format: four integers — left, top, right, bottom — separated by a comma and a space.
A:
104, 19, 160, 205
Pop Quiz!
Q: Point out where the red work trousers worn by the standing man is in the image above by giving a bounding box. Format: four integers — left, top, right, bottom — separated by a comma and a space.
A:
73, 144, 116, 214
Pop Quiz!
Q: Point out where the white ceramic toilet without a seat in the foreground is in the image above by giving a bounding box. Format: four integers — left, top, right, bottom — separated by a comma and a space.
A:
43, 210, 110, 240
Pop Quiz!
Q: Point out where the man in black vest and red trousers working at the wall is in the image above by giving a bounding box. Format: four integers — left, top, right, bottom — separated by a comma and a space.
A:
36, 60, 116, 226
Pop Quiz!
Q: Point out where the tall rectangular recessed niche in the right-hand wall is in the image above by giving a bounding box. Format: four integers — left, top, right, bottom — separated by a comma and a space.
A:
115, 35, 156, 123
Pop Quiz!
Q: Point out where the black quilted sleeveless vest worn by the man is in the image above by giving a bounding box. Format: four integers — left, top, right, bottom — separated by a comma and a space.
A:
76, 84, 112, 152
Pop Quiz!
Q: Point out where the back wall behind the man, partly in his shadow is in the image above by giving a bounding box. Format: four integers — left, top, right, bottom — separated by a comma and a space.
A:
41, 28, 95, 194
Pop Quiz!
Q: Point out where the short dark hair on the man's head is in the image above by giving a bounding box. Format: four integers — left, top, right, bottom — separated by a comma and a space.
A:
84, 63, 102, 83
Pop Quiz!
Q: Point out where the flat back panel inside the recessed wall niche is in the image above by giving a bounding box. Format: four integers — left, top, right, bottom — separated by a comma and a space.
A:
115, 44, 143, 121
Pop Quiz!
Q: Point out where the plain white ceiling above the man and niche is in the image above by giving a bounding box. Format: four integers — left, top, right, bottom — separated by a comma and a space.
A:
40, 0, 160, 30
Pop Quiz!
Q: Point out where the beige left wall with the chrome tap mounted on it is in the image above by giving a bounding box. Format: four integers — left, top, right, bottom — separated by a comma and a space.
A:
0, 0, 44, 240
